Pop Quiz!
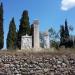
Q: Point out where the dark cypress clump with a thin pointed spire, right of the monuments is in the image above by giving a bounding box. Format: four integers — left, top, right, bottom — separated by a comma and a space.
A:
60, 20, 72, 47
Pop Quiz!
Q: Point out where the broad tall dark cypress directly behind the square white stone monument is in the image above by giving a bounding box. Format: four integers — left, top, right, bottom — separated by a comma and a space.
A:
17, 10, 30, 48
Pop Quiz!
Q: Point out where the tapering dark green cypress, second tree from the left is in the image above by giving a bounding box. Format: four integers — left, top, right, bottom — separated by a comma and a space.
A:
7, 18, 17, 49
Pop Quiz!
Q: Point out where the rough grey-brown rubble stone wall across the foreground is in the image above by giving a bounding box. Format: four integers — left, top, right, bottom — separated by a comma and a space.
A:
0, 54, 75, 75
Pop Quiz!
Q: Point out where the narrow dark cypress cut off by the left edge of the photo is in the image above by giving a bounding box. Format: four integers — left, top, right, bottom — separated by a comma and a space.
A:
0, 3, 4, 49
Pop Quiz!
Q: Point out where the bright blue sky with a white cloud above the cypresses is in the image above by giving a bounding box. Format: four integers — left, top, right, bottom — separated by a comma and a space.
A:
0, 0, 75, 48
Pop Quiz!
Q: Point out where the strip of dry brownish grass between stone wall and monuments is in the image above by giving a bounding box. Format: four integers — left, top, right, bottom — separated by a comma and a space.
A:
0, 48, 75, 56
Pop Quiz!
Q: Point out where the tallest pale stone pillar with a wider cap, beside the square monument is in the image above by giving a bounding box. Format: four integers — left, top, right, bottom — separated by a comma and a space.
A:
33, 20, 40, 49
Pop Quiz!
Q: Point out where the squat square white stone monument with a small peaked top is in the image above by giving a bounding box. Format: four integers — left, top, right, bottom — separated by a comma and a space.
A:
21, 34, 32, 50
